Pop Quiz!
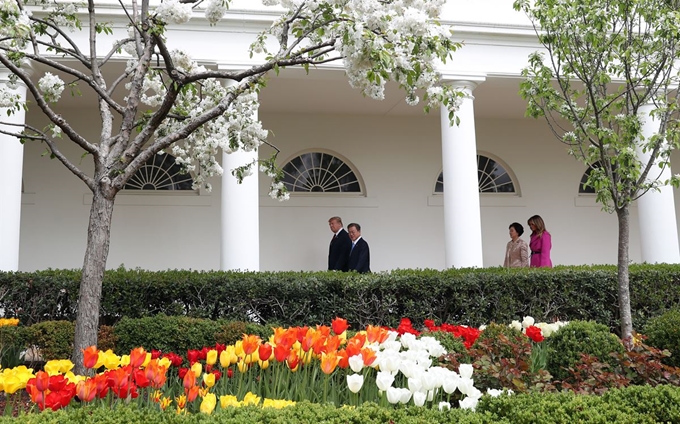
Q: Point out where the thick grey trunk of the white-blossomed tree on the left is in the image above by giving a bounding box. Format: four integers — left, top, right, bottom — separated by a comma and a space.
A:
72, 187, 114, 375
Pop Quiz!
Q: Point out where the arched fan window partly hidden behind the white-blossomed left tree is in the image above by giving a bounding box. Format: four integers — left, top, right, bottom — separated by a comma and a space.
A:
124, 153, 194, 190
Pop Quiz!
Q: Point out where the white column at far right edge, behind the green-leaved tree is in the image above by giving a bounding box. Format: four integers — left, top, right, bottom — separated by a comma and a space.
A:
637, 104, 680, 264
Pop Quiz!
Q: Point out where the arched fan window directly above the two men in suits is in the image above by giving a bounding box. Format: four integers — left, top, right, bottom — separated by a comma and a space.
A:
282, 152, 363, 193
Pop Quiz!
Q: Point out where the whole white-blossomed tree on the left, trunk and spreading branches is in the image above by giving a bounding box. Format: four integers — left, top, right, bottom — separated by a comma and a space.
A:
0, 0, 460, 372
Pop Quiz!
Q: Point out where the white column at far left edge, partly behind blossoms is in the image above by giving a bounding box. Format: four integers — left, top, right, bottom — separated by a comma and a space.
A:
0, 69, 26, 271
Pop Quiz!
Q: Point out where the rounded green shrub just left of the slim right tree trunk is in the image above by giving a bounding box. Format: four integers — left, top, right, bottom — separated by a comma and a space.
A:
546, 321, 624, 380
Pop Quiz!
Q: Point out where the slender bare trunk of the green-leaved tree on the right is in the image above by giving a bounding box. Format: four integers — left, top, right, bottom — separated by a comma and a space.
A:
616, 204, 633, 346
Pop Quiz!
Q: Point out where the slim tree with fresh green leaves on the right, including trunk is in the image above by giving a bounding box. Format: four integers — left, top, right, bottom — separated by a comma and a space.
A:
514, 0, 680, 339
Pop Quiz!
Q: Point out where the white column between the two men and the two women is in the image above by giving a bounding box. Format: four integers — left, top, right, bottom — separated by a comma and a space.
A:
441, 81, 483, 268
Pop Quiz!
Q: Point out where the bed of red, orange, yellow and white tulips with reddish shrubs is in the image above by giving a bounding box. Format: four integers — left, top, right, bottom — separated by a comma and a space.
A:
0, 317, 680, 415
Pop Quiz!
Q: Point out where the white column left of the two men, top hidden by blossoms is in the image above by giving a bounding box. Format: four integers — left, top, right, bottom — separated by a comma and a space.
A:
220, 80, 260, 271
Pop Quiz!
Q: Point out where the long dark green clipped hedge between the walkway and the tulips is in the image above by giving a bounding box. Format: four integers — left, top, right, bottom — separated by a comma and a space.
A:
0, 265, 680, 331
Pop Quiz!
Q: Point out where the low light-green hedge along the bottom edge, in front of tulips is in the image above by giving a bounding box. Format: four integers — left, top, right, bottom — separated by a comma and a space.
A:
0, 386, 680, 424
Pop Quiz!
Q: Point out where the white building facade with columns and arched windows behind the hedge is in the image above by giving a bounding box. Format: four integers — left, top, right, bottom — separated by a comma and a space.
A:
0, 0, 680, 271
